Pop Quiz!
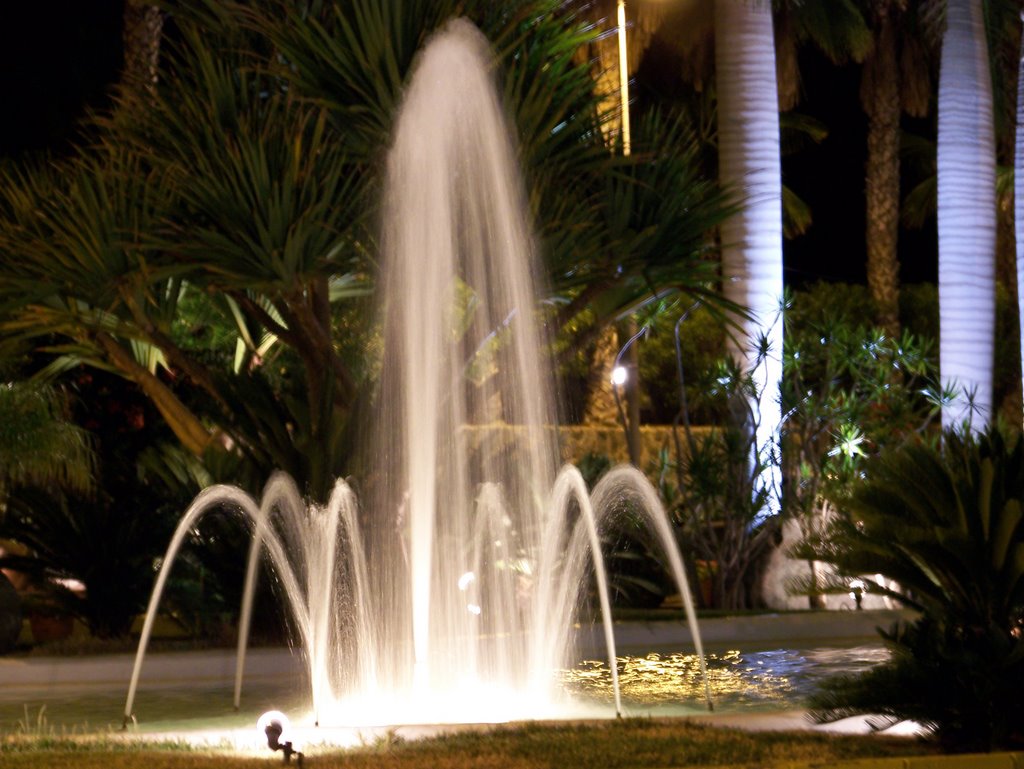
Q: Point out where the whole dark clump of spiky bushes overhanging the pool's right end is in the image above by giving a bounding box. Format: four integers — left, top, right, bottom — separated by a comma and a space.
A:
804, 430, 1024, 750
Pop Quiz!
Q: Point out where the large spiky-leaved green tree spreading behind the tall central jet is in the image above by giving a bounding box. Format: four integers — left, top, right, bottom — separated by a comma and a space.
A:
0, 0, 720, 495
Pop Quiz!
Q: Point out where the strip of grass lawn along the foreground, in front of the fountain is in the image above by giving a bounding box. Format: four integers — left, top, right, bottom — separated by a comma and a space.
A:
0, 719, 935, 769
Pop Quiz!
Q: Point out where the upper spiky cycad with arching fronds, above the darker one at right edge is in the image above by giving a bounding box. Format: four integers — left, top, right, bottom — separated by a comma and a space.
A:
806, 430, 1024, 632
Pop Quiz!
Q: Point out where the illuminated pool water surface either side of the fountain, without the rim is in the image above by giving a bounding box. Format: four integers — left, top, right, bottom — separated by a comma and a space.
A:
0, 644, 888, 734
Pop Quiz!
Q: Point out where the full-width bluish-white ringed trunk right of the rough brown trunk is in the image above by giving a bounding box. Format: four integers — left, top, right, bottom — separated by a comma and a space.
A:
938, 0, 995, 430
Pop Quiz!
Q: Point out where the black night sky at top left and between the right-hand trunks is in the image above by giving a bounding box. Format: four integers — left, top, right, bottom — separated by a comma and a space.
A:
0, 6, 936, 285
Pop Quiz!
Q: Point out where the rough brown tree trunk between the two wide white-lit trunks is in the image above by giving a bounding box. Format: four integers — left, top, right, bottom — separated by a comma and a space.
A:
861, 3, 900, 338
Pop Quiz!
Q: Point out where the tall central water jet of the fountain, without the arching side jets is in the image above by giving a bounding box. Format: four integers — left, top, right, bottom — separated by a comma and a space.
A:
375, 19, 558, 700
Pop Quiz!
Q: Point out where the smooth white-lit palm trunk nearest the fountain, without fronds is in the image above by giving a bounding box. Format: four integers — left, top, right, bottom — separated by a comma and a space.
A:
715, 0, 782, 512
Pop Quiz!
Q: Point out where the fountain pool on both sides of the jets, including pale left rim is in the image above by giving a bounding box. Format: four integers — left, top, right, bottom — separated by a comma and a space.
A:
0, 638, 888, 744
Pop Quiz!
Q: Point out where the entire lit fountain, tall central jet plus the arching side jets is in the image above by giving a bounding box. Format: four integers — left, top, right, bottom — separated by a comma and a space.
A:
125, 19, 711, 725
